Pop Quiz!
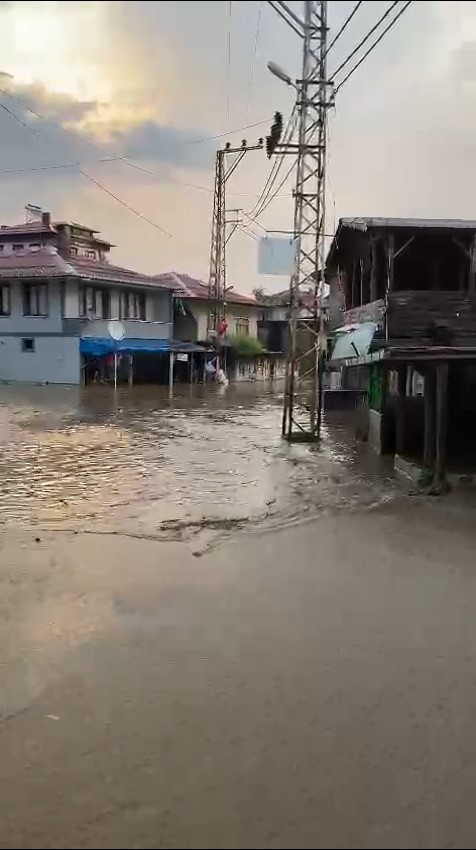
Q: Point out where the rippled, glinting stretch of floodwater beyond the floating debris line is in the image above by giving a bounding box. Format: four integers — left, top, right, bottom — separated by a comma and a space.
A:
0, 384, 396, 539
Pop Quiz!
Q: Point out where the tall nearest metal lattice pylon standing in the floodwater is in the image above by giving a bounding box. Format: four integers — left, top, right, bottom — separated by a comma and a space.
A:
282, 0, 330, 441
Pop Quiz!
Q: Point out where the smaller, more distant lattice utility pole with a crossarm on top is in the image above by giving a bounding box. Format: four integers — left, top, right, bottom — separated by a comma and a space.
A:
207, 139, 263, 337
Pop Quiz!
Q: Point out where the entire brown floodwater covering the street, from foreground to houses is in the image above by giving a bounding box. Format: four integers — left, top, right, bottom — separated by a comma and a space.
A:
0, 386, 476, 850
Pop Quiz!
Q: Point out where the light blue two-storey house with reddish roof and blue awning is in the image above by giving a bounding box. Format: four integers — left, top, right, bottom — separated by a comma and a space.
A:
0, 213, 201, 384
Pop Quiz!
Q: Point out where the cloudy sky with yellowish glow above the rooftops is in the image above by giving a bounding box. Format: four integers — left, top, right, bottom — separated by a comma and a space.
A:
0, 0, 476, 292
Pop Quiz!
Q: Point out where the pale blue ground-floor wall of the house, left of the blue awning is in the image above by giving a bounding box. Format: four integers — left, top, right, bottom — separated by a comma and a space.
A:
0, 332, 80, 384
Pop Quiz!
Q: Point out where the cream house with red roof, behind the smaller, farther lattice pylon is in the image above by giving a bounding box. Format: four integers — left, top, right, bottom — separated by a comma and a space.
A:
154, 272, 260, 342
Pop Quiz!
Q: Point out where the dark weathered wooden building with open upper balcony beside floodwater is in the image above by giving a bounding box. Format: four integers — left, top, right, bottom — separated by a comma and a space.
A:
326, 218, 476, 482
